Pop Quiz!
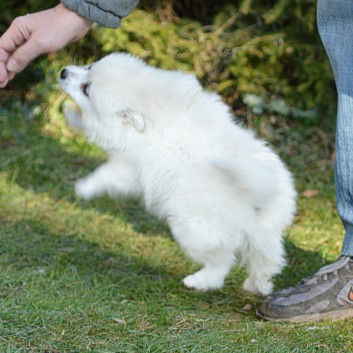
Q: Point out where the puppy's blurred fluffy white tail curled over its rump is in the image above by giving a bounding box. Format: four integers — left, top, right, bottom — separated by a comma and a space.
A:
212, 155, 283, 207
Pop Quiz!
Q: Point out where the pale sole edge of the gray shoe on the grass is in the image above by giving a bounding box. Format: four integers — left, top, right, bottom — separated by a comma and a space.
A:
256, 308, 353, 324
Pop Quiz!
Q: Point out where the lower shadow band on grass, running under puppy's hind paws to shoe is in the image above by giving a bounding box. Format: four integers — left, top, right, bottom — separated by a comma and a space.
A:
0, 220, 328, 302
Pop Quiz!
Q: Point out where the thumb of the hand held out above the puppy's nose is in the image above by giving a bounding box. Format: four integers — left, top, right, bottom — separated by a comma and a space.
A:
6, 39, 41, 73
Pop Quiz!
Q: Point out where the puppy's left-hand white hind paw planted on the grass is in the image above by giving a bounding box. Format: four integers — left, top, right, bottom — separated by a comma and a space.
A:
183, 269, 224, 292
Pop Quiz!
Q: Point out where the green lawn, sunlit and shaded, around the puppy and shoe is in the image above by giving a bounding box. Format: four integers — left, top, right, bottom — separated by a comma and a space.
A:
0, 93, 353, 353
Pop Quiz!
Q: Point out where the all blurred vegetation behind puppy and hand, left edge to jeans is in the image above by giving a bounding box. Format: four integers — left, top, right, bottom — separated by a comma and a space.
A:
0, 0, 336, 159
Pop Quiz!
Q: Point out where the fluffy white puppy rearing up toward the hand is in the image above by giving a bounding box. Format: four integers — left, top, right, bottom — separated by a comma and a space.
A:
60, 54, 296, 295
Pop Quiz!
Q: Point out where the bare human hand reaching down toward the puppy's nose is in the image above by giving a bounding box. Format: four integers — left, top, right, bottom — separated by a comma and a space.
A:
0, 4, 92, 88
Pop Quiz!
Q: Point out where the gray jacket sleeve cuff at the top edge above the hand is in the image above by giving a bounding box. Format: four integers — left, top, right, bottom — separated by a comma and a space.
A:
60, 0, 139, 28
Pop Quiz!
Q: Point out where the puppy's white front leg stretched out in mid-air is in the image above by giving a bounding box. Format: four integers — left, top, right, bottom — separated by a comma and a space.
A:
75, 160, 140, 200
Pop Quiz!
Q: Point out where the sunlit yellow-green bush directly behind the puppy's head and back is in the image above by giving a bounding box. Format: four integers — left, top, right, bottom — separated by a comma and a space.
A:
96, 1, 334, 116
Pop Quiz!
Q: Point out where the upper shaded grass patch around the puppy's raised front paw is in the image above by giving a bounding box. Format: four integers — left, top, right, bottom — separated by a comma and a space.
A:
0, 115, 168, 235
